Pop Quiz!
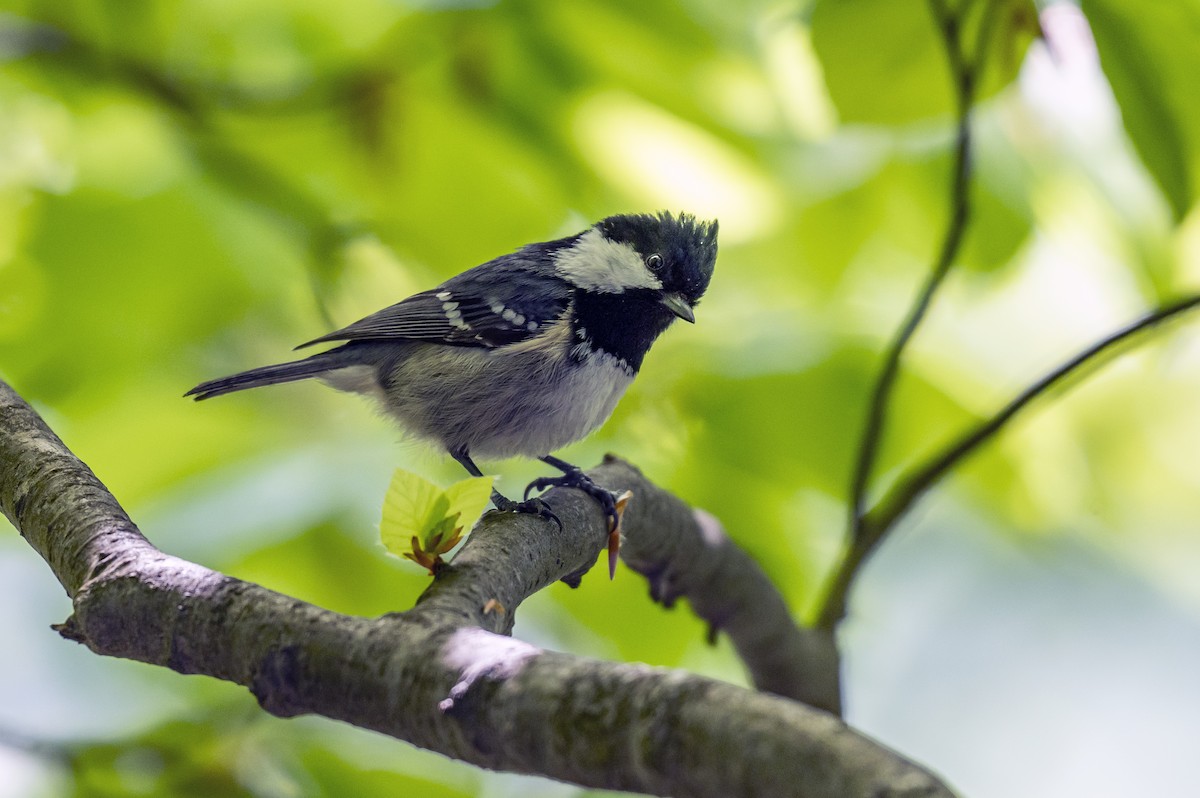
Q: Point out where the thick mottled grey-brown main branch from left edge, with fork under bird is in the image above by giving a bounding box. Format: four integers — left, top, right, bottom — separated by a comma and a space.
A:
0, 383, 952, 797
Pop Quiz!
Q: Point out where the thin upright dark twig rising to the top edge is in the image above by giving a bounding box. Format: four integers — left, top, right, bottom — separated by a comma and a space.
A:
848, 0, 983, 545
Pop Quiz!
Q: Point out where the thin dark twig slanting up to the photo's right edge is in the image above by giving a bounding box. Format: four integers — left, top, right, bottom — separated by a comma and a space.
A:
816, 295, 1200, 630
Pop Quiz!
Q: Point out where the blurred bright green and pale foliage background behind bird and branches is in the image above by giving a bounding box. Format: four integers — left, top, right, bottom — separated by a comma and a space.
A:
0, 0, 1200, 798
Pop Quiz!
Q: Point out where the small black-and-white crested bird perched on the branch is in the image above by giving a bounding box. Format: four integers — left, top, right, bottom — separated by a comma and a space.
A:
185, 211, 718, 534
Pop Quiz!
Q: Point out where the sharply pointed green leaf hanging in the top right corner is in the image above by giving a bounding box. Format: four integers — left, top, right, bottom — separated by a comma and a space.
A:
1082, 0, 1200, 221
